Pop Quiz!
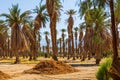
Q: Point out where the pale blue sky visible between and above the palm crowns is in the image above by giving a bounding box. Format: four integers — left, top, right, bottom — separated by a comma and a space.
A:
0, 0, 83, 45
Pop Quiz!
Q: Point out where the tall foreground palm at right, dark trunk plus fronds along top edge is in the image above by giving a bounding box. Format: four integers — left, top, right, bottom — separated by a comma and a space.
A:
79, 0, 120, 80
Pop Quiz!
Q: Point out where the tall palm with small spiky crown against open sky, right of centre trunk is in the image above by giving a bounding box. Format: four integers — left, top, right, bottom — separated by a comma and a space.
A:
66, 9, 76, 59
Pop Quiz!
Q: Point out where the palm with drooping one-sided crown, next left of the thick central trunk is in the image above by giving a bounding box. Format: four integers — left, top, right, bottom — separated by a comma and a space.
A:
33, 3, 48, 60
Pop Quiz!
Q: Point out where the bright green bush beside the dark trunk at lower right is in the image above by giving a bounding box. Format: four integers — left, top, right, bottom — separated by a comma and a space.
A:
96, 58, 112, 80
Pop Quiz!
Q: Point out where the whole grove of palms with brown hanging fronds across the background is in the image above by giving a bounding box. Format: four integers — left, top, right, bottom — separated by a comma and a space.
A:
0, 0, 120, 77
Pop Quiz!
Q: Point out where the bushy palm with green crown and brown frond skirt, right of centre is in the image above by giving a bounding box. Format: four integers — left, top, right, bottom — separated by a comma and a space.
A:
81, 1, 111, 64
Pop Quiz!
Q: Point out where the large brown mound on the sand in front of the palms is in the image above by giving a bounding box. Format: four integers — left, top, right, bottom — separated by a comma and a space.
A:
24, 60, 78, 75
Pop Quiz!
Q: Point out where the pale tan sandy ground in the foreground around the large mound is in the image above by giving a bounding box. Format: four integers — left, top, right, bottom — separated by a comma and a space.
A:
0, 63, 98, 80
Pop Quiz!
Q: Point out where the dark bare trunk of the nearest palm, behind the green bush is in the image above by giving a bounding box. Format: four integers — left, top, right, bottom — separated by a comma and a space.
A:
110, 0, 120, 80
